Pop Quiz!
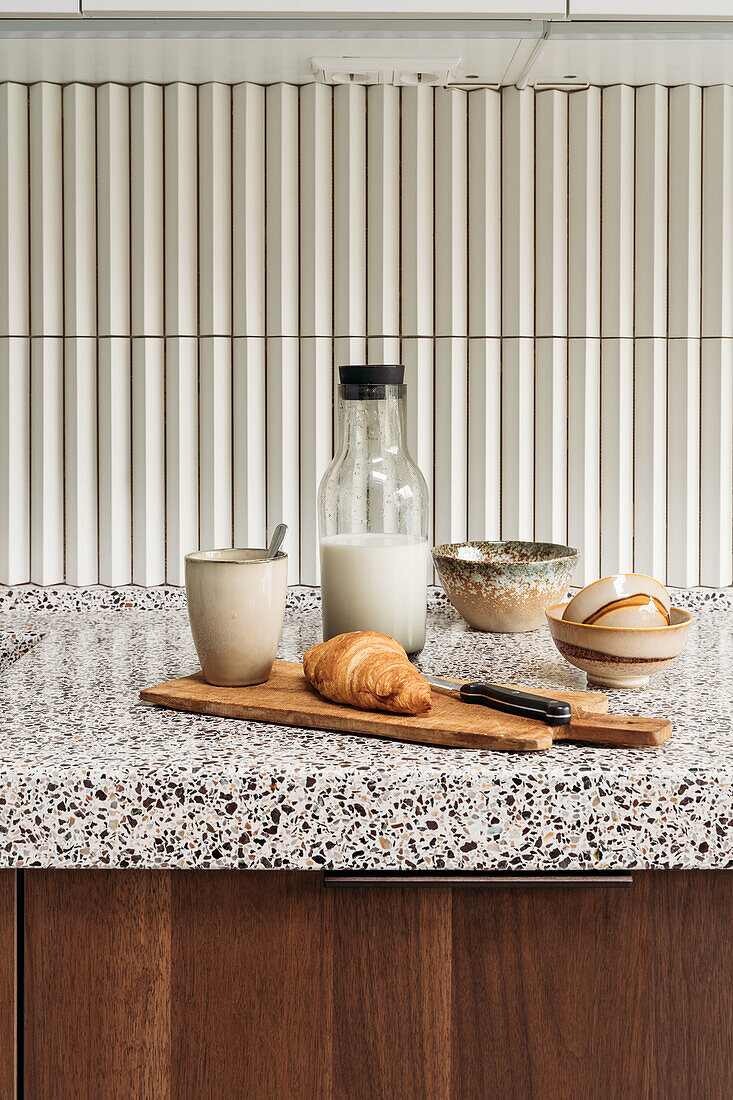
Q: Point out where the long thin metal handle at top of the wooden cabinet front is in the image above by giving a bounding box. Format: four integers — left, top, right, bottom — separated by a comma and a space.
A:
324, 871, 634, 890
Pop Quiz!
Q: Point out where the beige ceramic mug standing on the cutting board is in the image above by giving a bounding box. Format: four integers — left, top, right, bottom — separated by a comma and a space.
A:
186, 550, 287, 686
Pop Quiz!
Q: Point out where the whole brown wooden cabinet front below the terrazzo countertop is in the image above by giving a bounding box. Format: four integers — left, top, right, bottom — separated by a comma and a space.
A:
24, 871, 733, 1100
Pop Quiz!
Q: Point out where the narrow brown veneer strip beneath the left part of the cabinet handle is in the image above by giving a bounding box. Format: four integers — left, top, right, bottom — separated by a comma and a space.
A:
331, 889, 451, 1100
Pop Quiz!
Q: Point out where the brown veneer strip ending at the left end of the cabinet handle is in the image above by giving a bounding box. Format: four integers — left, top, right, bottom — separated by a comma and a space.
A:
171, 871, 330, 1100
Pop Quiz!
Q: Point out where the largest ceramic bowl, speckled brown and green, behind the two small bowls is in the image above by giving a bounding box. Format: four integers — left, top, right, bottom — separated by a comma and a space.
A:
433, 542, 578, 634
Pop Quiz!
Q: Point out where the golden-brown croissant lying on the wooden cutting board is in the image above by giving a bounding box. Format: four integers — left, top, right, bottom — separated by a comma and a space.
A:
303, 630, 430, 714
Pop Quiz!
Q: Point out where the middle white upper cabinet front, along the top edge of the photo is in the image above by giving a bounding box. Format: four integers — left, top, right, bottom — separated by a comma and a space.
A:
81, 0, 565, 19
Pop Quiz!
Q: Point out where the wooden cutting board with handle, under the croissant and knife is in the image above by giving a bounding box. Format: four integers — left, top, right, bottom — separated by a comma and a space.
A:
140, 661, 671, 752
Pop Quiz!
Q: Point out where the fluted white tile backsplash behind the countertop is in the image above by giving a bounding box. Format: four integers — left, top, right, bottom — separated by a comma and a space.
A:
0, 84, 733, 586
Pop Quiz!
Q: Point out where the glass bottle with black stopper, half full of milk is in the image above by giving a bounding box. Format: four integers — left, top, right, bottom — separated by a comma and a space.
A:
318, 366, 428, 653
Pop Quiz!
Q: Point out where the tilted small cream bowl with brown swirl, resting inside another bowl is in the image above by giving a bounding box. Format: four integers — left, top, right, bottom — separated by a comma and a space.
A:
562, 573, 671, 627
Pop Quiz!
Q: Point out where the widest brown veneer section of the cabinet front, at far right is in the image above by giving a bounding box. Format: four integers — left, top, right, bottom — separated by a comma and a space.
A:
452, 871, 733, 1100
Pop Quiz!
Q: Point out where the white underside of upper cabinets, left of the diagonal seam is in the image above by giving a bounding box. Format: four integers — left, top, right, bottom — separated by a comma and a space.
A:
0, 22, 526, 83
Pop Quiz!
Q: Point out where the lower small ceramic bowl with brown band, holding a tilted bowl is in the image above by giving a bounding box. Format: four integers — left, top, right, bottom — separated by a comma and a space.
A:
547, 604, 692, 688
